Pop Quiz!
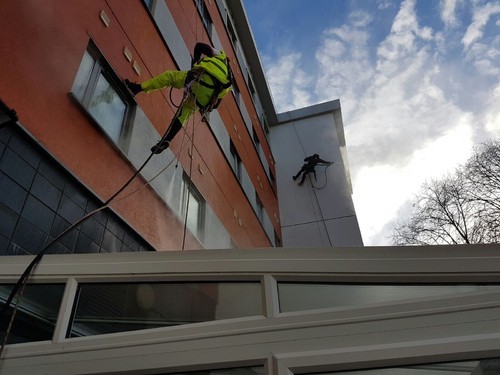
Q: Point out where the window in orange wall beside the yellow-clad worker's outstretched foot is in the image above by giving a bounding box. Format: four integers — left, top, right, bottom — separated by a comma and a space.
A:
71, 44, 131, 144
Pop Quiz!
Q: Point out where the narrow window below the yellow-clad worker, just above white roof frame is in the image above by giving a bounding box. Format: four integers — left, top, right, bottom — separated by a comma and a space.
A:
180, 174, 205, 241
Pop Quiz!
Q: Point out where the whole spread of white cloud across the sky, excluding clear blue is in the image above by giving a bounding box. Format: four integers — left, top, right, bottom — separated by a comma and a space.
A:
267, 0, 500, 245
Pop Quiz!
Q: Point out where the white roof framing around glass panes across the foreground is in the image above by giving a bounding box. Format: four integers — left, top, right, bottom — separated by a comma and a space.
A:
0, 245, 500, 375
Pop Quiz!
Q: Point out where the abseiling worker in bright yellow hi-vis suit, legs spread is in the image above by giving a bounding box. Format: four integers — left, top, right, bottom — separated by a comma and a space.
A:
125, 42, 233, 154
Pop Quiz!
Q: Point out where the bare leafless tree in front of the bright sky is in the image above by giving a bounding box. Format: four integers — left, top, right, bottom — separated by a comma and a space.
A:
392, 140, 500, 245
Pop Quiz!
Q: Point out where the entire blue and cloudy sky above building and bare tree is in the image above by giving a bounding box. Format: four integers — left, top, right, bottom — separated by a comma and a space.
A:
244, 0, 500, 245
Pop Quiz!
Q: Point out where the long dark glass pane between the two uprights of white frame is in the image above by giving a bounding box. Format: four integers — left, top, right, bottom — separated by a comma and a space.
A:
69, 282, 262, 337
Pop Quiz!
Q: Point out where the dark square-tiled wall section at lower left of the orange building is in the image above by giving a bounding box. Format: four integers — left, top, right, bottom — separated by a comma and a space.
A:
0, 126, 154, 258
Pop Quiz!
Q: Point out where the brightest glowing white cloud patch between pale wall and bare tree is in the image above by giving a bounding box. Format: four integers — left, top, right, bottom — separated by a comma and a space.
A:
353, 119, 473, 244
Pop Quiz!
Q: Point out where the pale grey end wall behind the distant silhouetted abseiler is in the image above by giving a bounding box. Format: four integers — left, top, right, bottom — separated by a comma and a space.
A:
271, 102, 362, 246
